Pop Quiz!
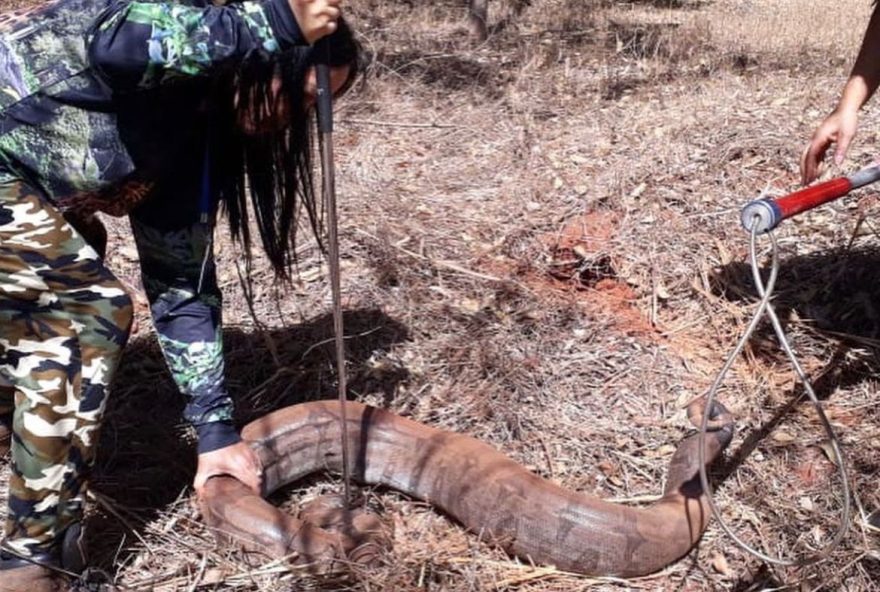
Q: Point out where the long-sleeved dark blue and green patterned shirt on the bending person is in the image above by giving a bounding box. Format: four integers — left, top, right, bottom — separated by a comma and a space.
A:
0, 0, 304, 452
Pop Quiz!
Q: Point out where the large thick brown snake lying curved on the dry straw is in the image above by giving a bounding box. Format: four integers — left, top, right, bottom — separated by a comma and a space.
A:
201, 401, 733, 577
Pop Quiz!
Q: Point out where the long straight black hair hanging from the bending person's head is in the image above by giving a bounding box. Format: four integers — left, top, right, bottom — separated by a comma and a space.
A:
208, 19, 361, 279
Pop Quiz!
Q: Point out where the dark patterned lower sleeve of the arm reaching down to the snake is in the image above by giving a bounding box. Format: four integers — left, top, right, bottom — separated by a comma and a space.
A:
131, 213, 240, 453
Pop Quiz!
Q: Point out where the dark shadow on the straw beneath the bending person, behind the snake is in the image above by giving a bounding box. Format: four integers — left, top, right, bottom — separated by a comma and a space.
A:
89, 310, 409, 566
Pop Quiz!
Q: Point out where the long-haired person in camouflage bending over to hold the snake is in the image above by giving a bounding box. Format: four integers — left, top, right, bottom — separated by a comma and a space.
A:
0, 0, 358, 592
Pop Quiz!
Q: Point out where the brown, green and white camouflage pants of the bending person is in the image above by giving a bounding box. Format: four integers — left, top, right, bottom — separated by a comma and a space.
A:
0, 182, 132, 554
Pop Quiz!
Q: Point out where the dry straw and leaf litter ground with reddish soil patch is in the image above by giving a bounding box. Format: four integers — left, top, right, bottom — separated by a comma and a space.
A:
1, 0, 880, 591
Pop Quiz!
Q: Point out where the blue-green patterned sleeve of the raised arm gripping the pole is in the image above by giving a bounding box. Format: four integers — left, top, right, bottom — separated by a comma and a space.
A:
89, 0, 305, 91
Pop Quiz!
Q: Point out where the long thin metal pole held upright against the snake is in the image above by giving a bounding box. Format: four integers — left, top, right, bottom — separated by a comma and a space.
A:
315, 38, 351, 509
